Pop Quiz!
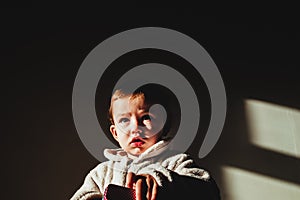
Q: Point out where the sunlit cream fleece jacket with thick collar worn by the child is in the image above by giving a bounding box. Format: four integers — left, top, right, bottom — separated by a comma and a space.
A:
71, 141, 210, 200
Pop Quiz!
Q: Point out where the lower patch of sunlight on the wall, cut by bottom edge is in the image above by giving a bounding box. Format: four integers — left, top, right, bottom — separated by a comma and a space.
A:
221, 166, 300, 200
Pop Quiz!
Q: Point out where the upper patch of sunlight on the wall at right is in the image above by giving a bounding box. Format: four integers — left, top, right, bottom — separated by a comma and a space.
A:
245, 99, 300, 158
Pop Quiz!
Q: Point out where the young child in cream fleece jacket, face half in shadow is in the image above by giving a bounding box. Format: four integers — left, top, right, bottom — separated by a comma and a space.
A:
71, 86, 220, 200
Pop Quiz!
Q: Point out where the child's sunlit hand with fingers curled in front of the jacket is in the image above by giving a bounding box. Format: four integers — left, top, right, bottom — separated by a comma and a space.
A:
126, 172, 158, 200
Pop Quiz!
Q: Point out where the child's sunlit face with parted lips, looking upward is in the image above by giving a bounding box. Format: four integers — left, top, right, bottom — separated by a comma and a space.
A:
110, 97, 163, 155
